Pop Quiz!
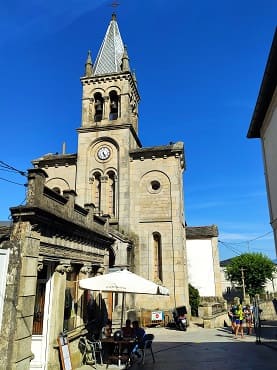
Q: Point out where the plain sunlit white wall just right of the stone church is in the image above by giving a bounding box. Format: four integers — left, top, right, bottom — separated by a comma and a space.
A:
186, 239, 216, 297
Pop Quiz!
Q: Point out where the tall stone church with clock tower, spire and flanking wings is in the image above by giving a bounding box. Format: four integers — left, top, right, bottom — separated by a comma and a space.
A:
33, 14, 188, 309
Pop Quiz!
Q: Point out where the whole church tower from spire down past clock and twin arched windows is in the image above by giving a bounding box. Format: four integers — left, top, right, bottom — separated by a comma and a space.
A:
76, 14, 141, 227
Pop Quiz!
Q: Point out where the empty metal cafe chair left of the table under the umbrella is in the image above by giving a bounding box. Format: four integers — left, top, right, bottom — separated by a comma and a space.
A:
79, 337, 103, 365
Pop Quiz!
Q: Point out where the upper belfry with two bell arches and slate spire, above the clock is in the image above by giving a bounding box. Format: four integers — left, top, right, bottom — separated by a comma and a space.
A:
81, 14, 139, 134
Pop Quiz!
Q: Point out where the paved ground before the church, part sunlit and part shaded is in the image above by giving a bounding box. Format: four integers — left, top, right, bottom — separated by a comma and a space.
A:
76, 321, 277, 370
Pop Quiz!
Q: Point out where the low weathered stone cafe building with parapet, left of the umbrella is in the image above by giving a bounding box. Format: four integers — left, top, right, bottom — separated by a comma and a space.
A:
0, 169, 114, 369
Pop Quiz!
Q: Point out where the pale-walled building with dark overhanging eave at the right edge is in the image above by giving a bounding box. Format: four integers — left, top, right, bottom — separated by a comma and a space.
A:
247, 30, 277, 253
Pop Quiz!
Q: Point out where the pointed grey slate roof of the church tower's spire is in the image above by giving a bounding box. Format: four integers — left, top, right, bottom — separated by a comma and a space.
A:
93, 14, 124, 76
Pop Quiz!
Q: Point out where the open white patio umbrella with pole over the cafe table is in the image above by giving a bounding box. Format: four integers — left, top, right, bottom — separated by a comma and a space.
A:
79, 270, 169, 327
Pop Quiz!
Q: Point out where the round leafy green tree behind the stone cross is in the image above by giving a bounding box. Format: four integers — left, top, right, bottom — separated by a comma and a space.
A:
226, 253, 276, 296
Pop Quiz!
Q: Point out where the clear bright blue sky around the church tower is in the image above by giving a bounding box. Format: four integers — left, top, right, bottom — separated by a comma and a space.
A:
0, 0, 277, 259
